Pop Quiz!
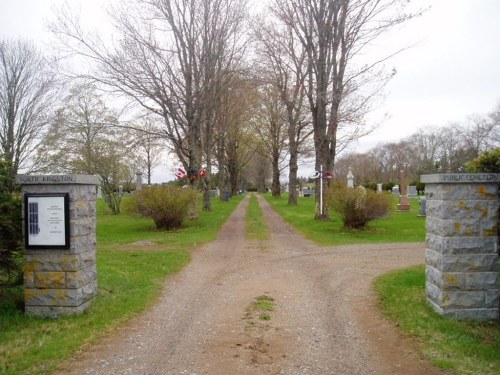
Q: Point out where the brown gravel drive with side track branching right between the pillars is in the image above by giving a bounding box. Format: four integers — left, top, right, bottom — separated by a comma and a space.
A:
56, 198, 439, 375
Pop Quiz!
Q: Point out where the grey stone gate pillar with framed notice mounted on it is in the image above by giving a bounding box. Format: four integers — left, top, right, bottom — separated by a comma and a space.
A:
16, 175, 98, 318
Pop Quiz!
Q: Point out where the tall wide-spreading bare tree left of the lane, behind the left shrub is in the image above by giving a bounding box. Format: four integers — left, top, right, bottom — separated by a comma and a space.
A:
52, 0, 246, 210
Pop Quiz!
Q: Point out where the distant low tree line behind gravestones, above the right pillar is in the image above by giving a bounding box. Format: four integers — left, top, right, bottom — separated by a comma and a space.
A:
335, 103, 500, 189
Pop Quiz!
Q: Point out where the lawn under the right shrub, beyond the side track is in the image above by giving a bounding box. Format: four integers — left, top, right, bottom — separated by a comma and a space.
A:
265, 194, 425, 246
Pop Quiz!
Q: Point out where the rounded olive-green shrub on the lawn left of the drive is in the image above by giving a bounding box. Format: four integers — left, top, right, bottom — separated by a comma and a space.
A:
135, 185, 199, 230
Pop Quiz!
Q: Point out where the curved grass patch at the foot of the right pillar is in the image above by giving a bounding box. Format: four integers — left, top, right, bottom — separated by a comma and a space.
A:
375, 266, 500, 375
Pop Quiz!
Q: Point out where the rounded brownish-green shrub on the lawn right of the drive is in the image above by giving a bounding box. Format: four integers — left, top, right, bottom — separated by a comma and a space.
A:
326, 184, 391, 229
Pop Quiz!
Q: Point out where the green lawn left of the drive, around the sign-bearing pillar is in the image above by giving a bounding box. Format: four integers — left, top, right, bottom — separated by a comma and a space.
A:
0, 196, 242, 374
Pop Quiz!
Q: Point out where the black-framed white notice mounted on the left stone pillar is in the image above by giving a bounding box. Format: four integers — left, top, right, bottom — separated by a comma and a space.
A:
24, 193, 70, 250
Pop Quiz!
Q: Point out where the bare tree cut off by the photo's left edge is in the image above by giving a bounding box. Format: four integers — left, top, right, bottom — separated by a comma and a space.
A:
0, 40, 56, 189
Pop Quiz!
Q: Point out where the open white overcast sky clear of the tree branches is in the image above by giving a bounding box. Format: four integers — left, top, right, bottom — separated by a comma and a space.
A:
0, 0, 500, 181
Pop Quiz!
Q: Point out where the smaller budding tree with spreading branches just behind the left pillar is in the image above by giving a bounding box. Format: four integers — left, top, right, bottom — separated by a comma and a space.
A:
37, 84, 136, 214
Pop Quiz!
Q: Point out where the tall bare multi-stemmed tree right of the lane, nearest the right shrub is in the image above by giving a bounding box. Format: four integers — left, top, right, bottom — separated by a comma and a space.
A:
272, 0, 409, 218
